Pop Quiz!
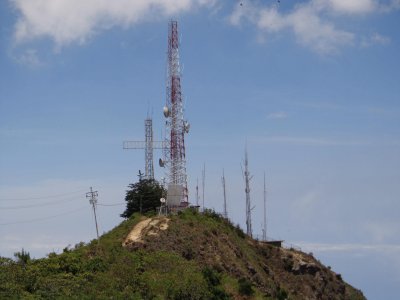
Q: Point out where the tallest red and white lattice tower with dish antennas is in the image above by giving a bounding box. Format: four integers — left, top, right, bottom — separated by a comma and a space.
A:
162, 21, 189, 206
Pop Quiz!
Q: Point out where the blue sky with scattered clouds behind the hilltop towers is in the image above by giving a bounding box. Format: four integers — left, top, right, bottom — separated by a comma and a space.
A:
0, 0, 400, 299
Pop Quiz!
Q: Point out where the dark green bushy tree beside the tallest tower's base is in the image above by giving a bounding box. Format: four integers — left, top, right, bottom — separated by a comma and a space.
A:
121, 179, 164, 218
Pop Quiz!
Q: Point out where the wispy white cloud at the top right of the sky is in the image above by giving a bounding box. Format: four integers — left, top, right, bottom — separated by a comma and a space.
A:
229, 0, 400, 55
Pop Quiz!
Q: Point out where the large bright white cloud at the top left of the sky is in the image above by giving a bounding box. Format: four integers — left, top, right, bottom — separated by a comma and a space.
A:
10, 0, 216, 46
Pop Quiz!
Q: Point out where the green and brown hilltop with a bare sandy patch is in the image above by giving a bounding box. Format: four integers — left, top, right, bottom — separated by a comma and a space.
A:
0, 210, 365, 299
